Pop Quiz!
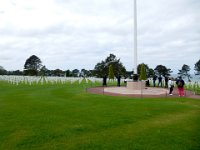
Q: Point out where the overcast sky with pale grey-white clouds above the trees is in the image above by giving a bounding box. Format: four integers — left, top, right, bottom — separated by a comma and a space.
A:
0, 0, 200, 73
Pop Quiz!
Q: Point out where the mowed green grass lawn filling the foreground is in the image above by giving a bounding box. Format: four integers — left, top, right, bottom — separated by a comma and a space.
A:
0, 82, 200, 150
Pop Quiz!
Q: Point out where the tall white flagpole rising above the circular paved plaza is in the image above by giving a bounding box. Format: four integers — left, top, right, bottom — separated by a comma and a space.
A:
133, 0, 138, 74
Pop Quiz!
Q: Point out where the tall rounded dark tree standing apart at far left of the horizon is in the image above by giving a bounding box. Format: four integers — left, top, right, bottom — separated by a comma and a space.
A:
24, 55, 42, 76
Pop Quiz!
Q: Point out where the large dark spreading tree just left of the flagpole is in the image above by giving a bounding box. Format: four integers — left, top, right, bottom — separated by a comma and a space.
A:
94, 54, 126, 77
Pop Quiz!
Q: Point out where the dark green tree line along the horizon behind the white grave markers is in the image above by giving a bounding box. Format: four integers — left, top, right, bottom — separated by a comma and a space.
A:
0, 54, 200, 80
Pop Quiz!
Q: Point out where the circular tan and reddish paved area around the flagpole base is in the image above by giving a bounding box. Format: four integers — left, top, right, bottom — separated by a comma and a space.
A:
87, 87, 200, 100
